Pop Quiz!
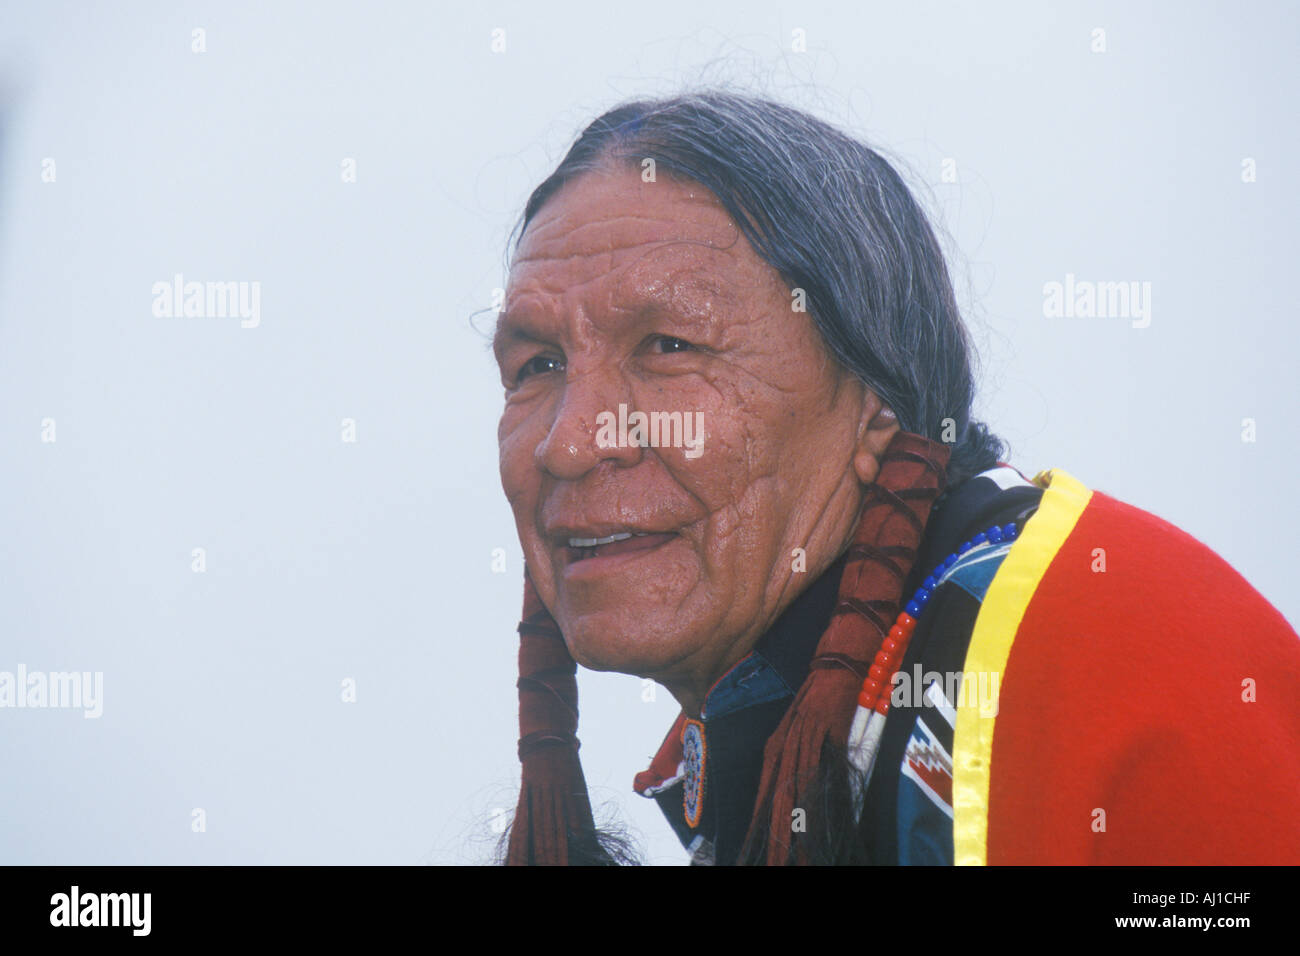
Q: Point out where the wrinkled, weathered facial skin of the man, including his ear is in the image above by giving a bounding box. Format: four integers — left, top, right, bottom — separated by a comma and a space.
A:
494, 168, 898, 715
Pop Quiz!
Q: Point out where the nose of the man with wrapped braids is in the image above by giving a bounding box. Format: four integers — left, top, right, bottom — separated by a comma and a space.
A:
534, 369, 641, 481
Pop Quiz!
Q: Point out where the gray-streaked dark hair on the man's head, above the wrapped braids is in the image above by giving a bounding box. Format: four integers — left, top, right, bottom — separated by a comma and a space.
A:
515, 90, 1006, 488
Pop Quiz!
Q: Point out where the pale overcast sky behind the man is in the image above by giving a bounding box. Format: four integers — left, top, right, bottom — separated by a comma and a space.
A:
0, 0, 1300, 864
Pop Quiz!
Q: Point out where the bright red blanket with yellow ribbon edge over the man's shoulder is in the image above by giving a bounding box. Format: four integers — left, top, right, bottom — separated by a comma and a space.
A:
953, 468, 1300, 865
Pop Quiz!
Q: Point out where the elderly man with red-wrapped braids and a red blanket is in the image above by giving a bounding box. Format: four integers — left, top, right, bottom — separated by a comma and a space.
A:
494, 92, 1300, 864
